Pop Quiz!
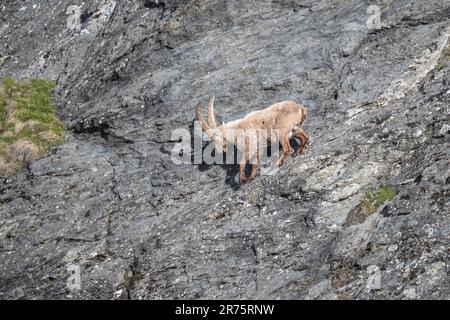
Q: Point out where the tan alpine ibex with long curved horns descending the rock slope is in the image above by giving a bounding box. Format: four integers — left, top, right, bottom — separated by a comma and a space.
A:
195, 97, 308, 184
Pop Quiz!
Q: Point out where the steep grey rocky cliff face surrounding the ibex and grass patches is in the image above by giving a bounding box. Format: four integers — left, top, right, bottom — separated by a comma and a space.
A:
0, 0, 450, 299
